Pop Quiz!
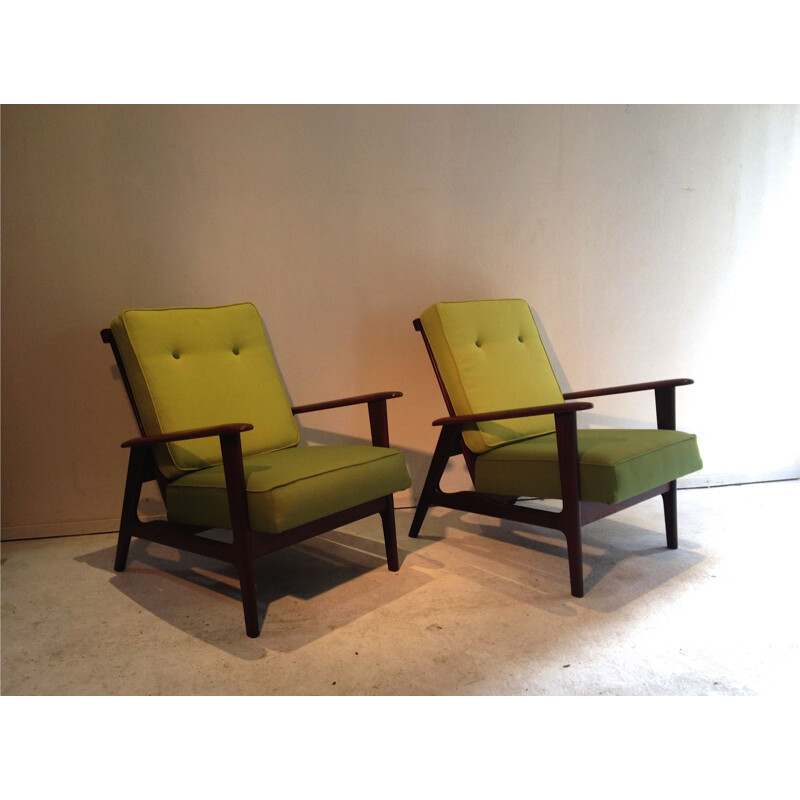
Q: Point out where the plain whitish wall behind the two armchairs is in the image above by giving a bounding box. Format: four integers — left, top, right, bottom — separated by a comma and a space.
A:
2, 106, 800, 538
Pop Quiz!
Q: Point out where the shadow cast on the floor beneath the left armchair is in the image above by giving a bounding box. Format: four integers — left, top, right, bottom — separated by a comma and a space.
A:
77, 530, 431, 660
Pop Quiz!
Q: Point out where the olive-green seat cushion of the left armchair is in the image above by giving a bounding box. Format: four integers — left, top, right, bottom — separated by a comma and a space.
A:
167, 446, 411, 533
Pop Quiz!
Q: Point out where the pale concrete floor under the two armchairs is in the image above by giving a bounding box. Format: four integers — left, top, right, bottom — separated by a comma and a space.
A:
0, 481, 800, 698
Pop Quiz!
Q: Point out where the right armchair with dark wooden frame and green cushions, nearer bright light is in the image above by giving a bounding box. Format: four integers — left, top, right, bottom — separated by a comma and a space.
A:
409, 300, 702, 597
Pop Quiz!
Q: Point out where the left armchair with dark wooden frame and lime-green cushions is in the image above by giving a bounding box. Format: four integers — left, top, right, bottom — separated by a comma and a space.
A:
101, 303, 411, 637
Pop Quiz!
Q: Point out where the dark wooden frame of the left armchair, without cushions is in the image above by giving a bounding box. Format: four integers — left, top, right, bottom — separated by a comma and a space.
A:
100, 328, 403, 638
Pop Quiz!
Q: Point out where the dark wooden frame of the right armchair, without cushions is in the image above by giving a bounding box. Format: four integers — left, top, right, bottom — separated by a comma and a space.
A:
408, 319, 694, 597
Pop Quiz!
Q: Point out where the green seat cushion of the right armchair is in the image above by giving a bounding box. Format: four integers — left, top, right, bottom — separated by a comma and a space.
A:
475, 429, 703, 503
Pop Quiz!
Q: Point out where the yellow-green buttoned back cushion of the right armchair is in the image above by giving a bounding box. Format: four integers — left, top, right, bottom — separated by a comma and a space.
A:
420, 300, 564, 453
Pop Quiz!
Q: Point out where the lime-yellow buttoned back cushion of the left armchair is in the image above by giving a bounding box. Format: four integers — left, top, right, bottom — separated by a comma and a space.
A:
111, 303, 300, 479
